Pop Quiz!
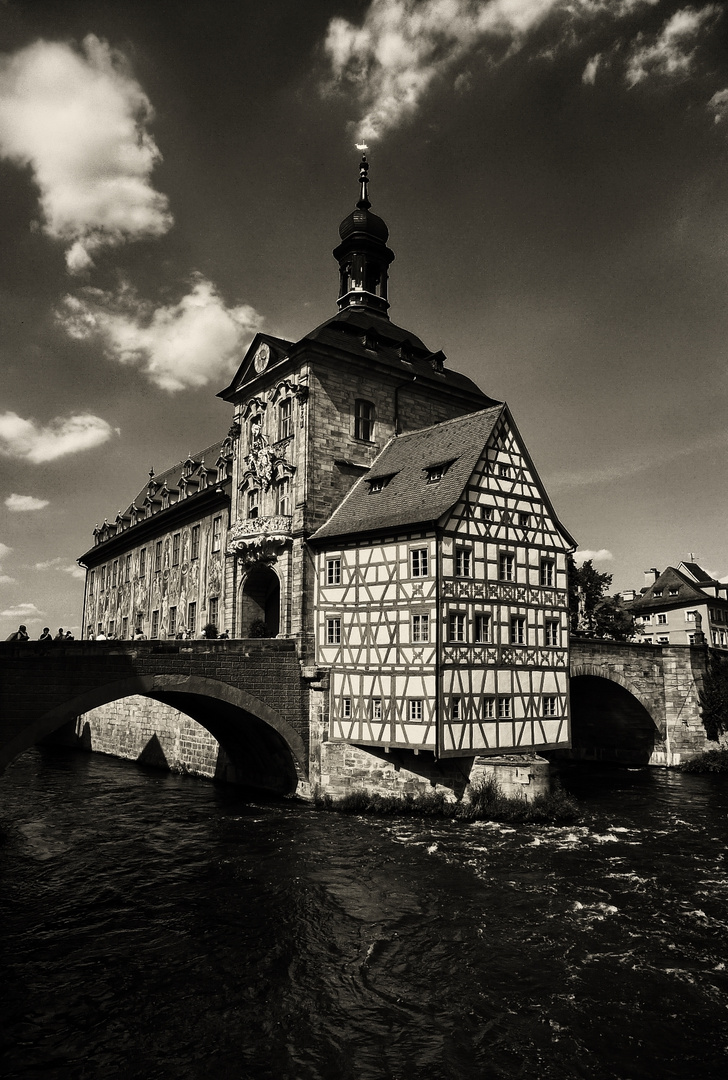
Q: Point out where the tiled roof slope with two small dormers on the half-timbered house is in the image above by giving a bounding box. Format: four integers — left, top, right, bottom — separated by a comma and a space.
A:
311, 405, 503, 542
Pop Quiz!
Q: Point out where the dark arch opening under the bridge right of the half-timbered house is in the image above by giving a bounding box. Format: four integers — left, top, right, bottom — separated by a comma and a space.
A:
569, 664, 663, 765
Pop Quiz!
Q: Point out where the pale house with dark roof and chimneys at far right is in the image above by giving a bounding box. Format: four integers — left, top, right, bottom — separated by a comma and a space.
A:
621, 563, 728, 649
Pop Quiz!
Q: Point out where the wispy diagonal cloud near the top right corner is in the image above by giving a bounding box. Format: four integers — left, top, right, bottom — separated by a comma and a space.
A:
625, 4, 720, 86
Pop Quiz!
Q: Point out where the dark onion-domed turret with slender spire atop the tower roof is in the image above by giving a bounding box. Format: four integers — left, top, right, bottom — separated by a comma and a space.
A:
334, 154, 394, 319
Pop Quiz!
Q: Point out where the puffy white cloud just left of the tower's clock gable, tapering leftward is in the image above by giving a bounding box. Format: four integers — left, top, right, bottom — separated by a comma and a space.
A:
57, 274, 262, 393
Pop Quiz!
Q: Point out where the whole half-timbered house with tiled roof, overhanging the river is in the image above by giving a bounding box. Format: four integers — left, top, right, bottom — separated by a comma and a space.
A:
311, 406, 572, 756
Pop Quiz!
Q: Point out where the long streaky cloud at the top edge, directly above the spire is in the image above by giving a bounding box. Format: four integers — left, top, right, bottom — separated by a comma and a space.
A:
324, 0, 658, 141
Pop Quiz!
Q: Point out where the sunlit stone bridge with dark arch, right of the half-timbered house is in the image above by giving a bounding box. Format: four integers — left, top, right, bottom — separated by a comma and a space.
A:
565, 637, 715, 765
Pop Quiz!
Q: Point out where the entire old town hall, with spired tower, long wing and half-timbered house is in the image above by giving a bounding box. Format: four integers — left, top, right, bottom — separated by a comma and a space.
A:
80, 159, 574, 786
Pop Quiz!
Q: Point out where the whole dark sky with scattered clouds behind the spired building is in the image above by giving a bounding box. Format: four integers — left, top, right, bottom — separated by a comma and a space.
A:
0, 0, 728, 637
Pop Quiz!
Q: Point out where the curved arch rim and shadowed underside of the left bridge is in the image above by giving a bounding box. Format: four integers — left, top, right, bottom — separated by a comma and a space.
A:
28, 674, 308, 794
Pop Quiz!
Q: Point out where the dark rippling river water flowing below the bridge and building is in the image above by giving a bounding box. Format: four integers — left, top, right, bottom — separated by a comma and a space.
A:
0, 747, 728, 1080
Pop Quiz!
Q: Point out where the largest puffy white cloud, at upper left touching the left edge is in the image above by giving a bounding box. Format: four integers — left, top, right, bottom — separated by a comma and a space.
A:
0, 33, 172, 273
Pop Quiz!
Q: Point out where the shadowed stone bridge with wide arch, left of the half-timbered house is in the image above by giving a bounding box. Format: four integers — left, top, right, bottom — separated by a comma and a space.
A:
0, 638, 309, 794
